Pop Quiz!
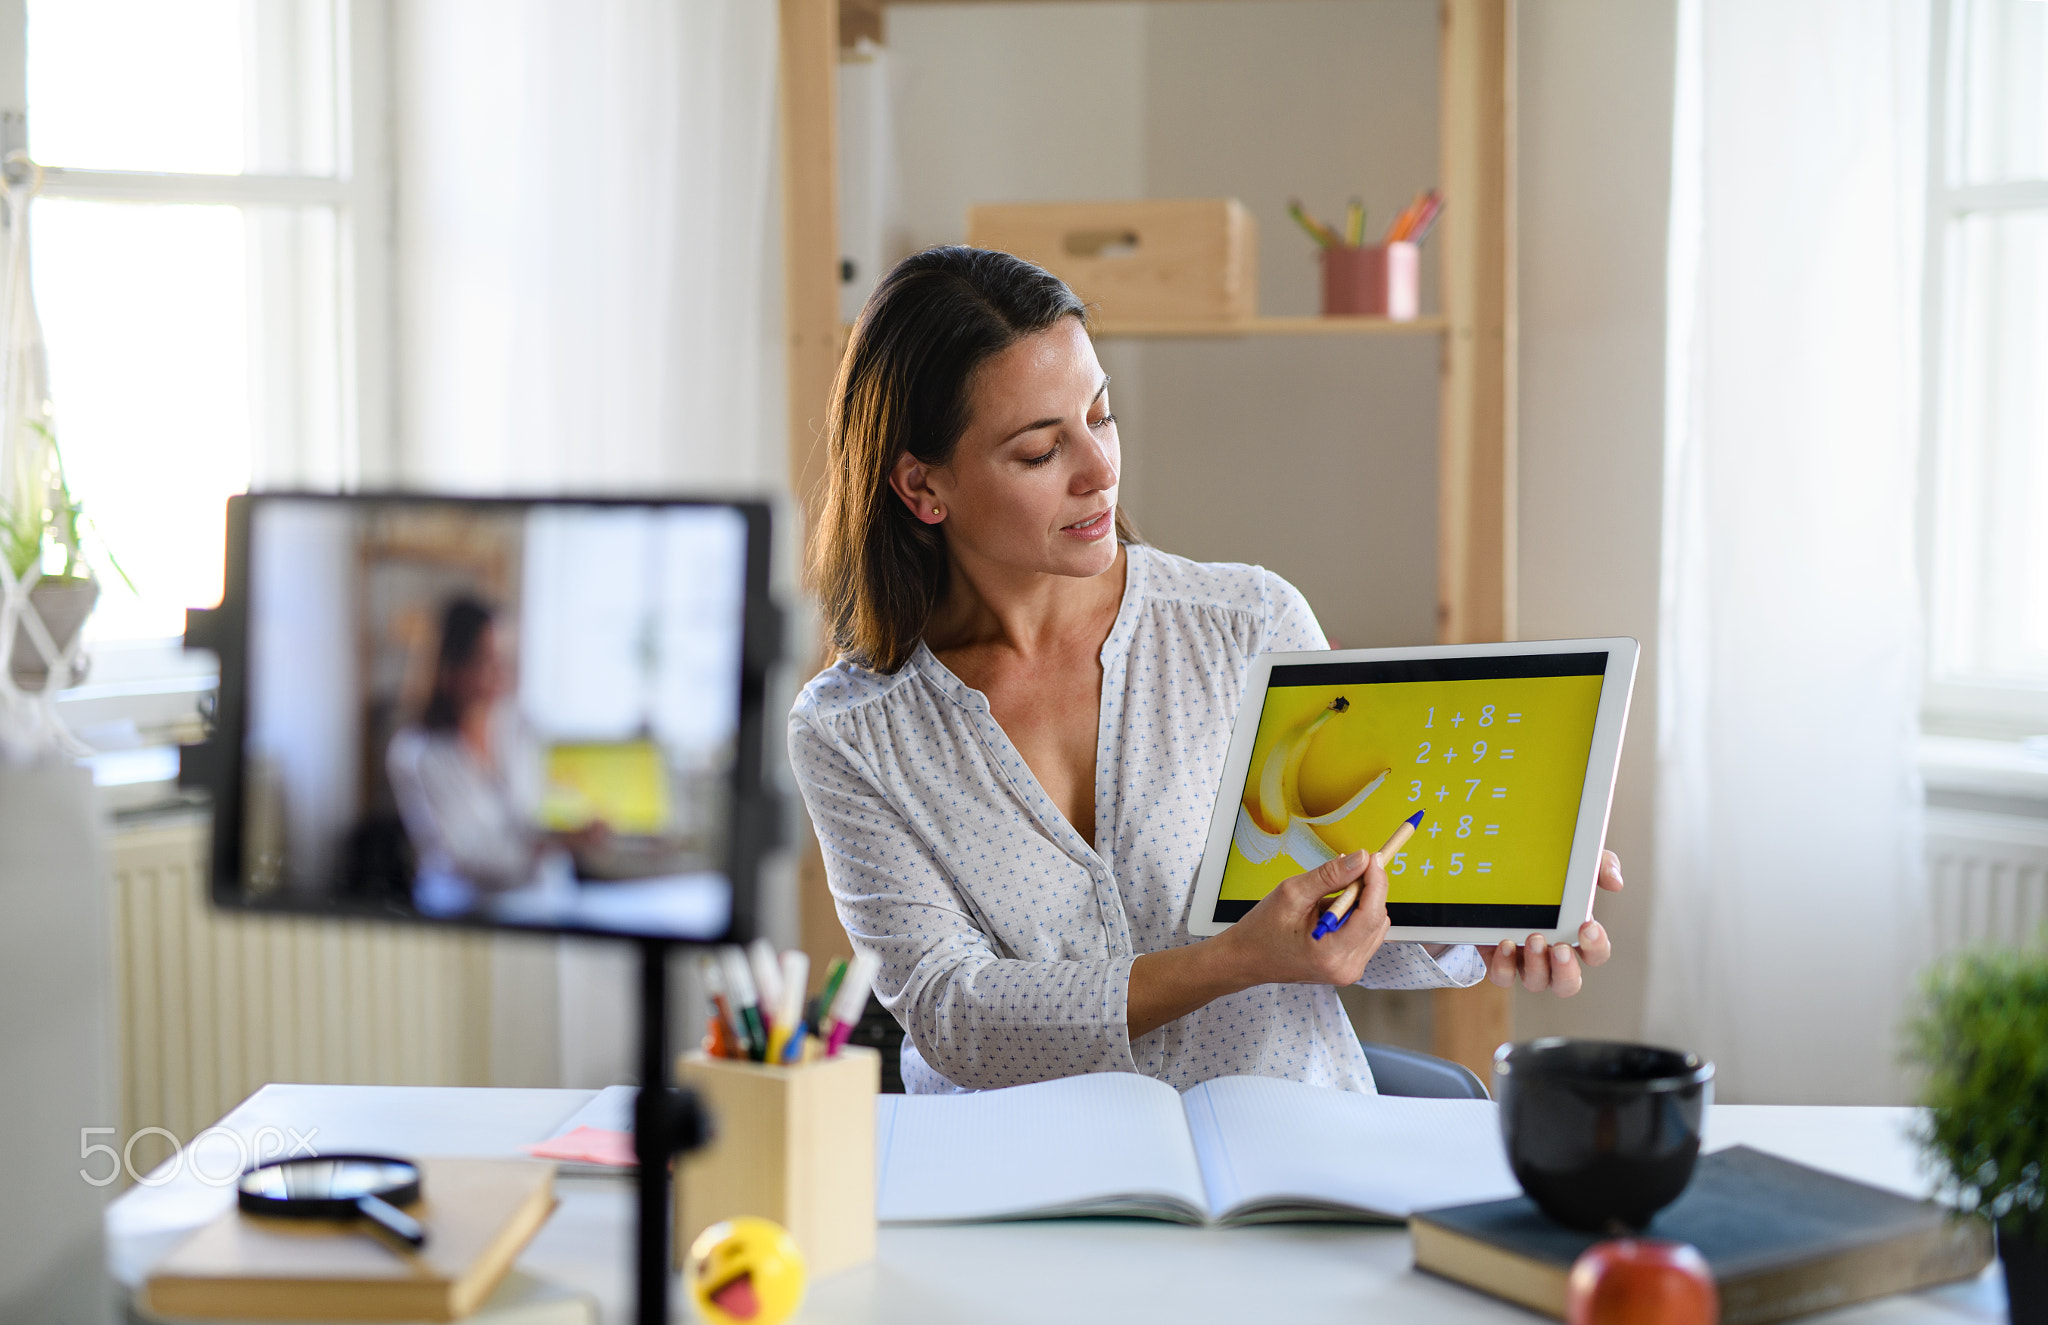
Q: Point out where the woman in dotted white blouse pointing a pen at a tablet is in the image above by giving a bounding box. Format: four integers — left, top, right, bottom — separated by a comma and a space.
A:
791, 248, 1620, 1092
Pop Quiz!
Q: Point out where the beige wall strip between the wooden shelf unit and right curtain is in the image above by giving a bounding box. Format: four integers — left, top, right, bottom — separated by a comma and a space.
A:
1516, 0, 1677, 1038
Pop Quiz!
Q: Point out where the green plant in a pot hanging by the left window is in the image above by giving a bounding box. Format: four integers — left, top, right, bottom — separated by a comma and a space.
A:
0, 422, 101, 690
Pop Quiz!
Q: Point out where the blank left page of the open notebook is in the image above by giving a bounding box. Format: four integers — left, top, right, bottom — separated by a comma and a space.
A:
874, 1073, 1208, 1223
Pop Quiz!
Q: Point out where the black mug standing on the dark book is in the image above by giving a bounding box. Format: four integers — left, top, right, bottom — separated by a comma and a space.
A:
1493, 1036, 1714, 1233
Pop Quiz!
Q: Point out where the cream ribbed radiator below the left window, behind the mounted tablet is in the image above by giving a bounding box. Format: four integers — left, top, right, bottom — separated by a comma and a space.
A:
113, 817, 492, 1173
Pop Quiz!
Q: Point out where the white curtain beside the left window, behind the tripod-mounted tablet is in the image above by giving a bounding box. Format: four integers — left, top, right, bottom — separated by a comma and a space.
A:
395, 0, 786, 1085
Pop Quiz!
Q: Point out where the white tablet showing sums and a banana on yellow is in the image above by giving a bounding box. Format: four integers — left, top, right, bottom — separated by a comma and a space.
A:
1188, 639, 1636, 944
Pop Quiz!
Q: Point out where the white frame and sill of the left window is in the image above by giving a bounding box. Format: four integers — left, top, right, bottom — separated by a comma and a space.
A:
0, 0, 399, 757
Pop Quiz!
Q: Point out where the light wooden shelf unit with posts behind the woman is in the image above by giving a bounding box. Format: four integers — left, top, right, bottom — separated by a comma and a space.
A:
778, 0, 1518, 1077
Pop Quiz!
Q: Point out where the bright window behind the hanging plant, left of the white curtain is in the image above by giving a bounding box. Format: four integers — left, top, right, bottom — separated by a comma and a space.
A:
0, 0, 391, 745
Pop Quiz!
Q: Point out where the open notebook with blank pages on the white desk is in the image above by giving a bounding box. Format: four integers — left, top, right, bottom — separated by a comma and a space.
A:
874, 1073, 1520, 1225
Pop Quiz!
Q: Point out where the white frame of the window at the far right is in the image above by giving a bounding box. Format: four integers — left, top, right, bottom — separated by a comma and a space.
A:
1917, 0, 2048, 741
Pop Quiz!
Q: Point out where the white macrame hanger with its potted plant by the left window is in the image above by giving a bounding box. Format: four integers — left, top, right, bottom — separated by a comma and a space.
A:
0, 152, 100, 762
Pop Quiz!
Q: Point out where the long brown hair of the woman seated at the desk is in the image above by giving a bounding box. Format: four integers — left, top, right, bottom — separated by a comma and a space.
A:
811, 246, 1139, 672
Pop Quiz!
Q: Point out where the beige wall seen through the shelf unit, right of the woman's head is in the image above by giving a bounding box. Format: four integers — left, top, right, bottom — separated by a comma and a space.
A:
1118, 0, 1438, 647
